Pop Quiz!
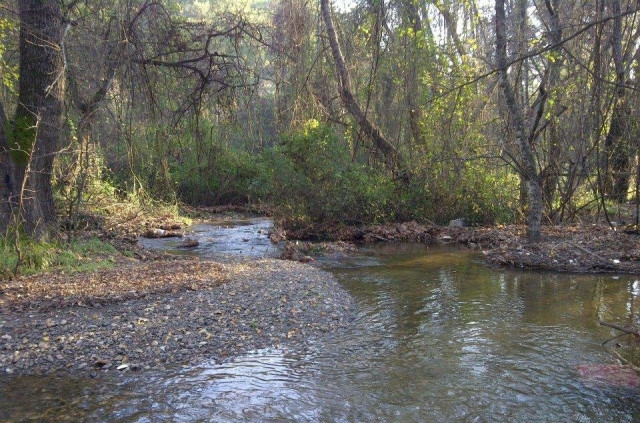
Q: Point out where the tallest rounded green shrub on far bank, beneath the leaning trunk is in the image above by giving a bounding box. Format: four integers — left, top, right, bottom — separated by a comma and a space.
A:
252, 120, 396, 227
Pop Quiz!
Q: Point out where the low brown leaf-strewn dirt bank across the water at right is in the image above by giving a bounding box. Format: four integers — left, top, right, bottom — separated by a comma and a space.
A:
276, 222, 640, 274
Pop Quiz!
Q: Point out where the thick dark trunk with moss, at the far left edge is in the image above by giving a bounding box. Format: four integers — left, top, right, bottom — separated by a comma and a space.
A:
4, 0, 64, 238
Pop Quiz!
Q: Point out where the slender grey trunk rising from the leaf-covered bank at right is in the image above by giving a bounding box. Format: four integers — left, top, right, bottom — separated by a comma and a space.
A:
495, 0, 542, 242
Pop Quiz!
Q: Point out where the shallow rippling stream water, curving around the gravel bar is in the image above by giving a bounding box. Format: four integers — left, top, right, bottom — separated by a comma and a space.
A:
0, 219, 640, 422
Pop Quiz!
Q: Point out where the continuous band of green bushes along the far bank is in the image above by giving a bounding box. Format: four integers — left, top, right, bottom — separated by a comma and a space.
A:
115, 119, 519, 228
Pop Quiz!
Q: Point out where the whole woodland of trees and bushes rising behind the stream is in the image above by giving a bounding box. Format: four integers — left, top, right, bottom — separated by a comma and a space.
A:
0, 0, 640, 240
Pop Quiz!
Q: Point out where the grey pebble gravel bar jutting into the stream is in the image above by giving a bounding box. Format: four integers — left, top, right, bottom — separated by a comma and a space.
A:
0, 259, 355, 376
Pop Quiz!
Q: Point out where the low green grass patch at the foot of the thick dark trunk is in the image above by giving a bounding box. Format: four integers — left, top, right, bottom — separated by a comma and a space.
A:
0, 238, 120, 280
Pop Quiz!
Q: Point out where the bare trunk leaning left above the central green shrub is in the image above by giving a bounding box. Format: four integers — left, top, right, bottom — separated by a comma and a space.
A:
320, 0, 397, 167
